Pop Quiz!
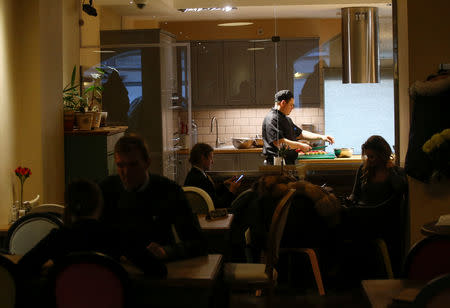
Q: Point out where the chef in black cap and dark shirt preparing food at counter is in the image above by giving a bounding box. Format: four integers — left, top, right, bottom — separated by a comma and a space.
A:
262, 90, 334, 165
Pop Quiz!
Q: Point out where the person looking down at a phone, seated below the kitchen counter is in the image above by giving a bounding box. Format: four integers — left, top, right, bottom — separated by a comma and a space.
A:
184, 143, 241, 208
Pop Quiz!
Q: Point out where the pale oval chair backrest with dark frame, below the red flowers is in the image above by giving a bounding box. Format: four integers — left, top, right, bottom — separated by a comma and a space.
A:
6, 213, 63, 255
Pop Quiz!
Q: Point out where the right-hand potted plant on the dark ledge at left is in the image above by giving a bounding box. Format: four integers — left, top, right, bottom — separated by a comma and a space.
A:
84, 67, 105, 128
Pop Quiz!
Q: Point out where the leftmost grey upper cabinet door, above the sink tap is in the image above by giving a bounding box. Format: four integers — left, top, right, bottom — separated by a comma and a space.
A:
191, 41, 224, 107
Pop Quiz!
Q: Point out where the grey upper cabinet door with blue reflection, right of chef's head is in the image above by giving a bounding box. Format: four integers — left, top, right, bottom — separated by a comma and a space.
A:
285, 38, 320, 107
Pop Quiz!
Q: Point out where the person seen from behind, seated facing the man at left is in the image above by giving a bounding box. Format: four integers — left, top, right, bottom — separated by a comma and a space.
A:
18, 180, 167, 277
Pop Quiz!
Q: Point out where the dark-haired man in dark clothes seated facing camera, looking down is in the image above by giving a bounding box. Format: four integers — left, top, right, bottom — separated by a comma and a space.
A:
100, 135, 206, 260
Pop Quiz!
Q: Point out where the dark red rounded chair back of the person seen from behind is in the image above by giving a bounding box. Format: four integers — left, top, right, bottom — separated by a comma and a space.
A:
49, 252, 129, 308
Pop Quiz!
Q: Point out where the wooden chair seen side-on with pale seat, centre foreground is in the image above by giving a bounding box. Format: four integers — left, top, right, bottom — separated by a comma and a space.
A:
224, 189, 295, 306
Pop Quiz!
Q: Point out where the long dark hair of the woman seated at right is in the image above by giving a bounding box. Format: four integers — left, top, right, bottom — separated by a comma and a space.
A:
361, 135, 392, 184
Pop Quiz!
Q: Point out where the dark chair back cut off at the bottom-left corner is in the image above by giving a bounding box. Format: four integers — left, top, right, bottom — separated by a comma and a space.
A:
0, 255, 17, 308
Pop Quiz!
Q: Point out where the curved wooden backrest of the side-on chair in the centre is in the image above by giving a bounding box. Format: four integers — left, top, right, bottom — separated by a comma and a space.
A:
266, 189, 295, 279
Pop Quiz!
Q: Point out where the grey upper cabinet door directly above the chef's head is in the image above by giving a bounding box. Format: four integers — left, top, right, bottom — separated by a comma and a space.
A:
254, 42, 287, 106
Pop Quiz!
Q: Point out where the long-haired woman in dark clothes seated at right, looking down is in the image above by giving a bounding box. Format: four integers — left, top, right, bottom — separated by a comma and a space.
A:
342, 135, 407, 278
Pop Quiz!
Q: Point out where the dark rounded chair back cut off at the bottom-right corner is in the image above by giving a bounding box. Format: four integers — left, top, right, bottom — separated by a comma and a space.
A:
413, 274, 450, 308
